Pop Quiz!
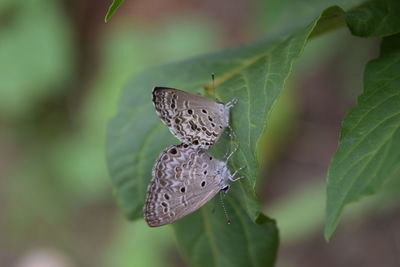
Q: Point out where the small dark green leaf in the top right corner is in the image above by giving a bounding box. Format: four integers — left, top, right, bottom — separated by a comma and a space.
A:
346, 0, 400, 37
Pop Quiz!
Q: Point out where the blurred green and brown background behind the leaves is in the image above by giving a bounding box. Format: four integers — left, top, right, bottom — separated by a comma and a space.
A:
0, 0, 400, 267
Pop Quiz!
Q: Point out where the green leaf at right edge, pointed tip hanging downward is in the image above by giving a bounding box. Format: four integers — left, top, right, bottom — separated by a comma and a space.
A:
325, 35, 400, 239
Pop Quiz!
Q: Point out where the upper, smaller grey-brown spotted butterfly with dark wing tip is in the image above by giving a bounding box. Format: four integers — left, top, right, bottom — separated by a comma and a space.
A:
153, 87, 237, 149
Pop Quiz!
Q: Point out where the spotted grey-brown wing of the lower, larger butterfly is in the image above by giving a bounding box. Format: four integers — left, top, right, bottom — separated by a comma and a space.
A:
144, 144, 221, 227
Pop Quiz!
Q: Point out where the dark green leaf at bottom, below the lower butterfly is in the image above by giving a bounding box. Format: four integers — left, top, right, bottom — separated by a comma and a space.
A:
174, 191, 278, 267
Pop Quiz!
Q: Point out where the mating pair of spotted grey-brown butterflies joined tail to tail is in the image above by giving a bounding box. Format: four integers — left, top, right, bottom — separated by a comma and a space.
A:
144, 87, 242, 227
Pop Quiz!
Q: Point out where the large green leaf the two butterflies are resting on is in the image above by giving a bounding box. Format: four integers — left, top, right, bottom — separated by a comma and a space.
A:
107, 5, 343, 224
